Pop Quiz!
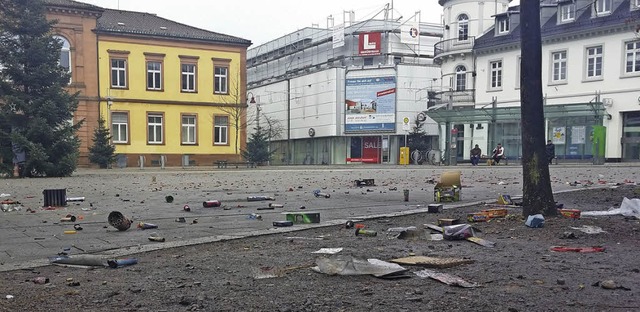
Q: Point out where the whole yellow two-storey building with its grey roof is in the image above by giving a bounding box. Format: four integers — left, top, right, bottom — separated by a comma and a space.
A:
95, 9, 251, 166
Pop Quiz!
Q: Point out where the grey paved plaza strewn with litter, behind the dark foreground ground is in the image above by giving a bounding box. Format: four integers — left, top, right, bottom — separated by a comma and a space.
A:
0, 164, 640, 271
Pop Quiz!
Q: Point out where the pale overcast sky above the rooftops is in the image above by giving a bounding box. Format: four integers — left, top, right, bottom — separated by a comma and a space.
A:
76, 0, 478, 47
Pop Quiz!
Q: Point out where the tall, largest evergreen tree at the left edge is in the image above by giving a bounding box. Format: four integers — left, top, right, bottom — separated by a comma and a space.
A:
0, 0, 81, 176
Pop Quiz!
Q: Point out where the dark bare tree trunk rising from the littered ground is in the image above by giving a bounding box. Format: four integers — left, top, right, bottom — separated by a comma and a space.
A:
520, 0, 557, 217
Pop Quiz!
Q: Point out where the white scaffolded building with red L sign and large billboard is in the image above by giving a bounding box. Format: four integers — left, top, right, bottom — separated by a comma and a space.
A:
247, 7, 442, 164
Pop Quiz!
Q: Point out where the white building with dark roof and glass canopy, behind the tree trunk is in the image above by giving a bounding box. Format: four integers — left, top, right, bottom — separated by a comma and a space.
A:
426, 0, 640, 162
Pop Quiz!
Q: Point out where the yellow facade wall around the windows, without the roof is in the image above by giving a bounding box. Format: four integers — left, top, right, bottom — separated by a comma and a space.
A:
99, 35, 246, 166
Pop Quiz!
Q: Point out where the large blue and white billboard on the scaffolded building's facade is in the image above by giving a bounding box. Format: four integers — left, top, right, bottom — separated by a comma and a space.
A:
344, 77, 396, 133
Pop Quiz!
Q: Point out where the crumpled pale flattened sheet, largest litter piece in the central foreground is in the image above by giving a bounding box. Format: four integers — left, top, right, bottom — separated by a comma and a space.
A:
312, 256, 407, 278
